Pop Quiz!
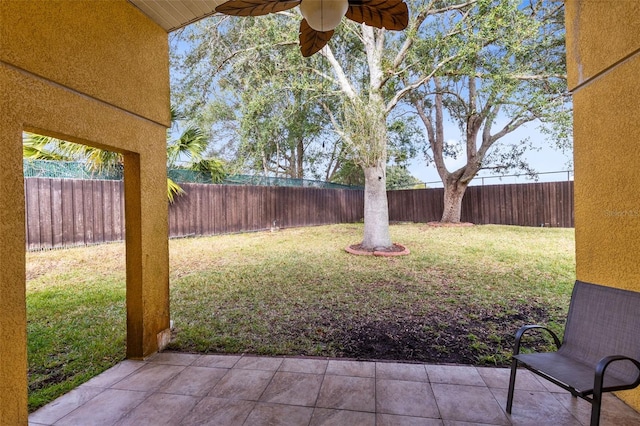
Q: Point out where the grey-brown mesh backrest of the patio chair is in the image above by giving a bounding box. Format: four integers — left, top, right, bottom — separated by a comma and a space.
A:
559, 281, 640, 379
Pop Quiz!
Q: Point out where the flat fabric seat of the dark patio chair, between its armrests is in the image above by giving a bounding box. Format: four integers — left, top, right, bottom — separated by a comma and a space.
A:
514, 352, 630, 396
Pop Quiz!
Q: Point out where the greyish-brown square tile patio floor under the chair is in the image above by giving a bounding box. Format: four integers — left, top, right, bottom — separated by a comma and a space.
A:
29, 352, 640, 426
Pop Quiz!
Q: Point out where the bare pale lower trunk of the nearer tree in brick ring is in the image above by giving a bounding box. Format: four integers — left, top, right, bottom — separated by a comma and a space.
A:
362, 160, 391, 250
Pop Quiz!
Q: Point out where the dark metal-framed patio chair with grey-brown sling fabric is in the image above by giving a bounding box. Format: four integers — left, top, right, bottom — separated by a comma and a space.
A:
507, 281, 640, 426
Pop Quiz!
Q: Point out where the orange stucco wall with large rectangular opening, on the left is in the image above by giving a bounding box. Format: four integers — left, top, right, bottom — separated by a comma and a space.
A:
0, 0, 170, 425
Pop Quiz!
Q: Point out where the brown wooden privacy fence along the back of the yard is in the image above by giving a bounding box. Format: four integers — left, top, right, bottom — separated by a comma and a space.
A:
25, 178, 573, 250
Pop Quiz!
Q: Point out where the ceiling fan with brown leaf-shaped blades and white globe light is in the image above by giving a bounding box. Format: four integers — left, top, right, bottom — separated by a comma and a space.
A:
216, 0, 409, 57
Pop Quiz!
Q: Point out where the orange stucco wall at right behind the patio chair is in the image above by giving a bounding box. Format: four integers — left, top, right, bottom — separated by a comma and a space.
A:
566, 0, 640, 410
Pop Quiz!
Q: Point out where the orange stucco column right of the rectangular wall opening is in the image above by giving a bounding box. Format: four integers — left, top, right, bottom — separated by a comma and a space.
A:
124, 151, 171, 359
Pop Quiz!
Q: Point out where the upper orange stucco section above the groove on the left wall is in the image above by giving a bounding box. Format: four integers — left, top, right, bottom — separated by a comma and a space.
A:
0, 0, 170, 125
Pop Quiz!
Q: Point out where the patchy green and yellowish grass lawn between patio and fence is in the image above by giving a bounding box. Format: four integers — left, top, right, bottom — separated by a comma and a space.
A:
27, 224, 575, 409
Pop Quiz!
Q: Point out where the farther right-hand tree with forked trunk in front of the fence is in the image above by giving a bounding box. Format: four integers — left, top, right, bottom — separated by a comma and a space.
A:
406, 0, 571, 222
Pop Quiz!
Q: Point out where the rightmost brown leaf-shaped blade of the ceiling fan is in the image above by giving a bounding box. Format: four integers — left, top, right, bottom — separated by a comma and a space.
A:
345, 0, 409, 31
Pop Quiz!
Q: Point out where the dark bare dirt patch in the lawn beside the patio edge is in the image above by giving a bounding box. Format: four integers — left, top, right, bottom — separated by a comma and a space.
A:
316, 305, 550, 366
